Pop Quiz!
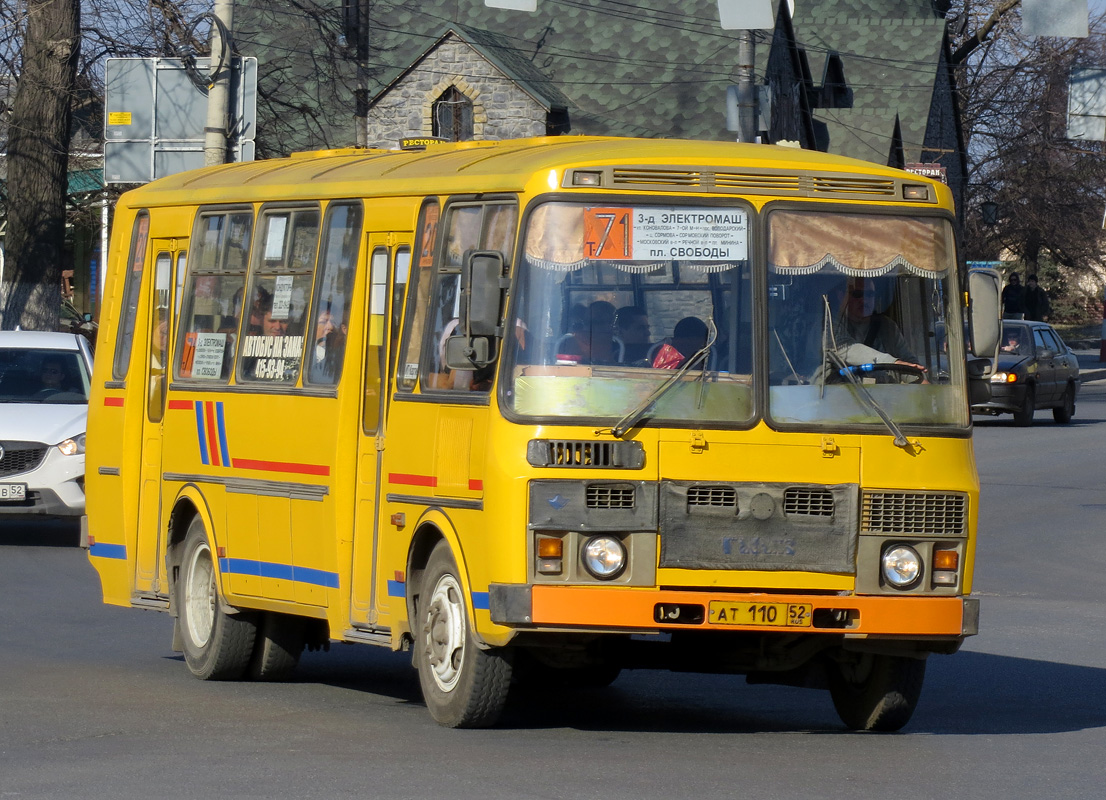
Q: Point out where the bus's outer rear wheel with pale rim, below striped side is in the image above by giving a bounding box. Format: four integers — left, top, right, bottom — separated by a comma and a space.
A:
176, 517, 257, 680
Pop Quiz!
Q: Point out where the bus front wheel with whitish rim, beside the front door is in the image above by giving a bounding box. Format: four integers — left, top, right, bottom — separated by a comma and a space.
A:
415, 541, 511, 728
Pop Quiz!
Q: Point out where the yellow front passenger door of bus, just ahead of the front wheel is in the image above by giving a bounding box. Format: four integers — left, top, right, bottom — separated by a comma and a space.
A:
349, 241, 410, 630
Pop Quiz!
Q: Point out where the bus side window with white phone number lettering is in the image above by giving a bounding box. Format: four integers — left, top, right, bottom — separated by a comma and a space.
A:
237, 208, 319, 384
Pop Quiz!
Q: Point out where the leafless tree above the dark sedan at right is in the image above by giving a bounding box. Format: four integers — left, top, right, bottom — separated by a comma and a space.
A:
950, 0, 1106, 323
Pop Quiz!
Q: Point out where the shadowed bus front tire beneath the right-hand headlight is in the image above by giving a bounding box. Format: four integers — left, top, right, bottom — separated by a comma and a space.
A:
830, 653, 926, 731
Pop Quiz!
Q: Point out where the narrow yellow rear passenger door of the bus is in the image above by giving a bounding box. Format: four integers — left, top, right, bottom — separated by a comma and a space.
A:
135, 237, 187, 594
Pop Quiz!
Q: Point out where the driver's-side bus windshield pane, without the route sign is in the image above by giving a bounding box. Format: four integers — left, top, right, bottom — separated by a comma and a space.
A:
768, 209, 969, 426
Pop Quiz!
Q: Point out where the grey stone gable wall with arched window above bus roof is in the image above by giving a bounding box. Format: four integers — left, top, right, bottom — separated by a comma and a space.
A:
368, 37, 546, 147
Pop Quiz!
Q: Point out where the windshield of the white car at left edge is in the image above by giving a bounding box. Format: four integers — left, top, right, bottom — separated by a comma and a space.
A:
0, 347, 88, 405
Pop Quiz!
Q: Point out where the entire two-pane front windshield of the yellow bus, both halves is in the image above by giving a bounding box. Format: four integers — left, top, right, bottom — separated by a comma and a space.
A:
504, 202, 969, 435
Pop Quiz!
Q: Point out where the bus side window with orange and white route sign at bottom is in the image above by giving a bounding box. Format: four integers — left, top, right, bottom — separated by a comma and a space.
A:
174, 208, 253, 382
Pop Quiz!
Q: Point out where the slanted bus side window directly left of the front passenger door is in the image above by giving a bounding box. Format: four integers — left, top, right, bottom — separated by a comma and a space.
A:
305, 202, 363, 386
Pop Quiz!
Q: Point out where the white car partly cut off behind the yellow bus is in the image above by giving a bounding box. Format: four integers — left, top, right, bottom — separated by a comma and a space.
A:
0, 331, 92, 520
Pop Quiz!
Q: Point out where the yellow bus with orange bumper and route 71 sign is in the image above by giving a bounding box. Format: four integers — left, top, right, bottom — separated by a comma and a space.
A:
83, 137, 998, 730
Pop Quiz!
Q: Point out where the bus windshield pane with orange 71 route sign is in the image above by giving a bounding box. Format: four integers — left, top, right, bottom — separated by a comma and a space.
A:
504, 202, 753, 425
